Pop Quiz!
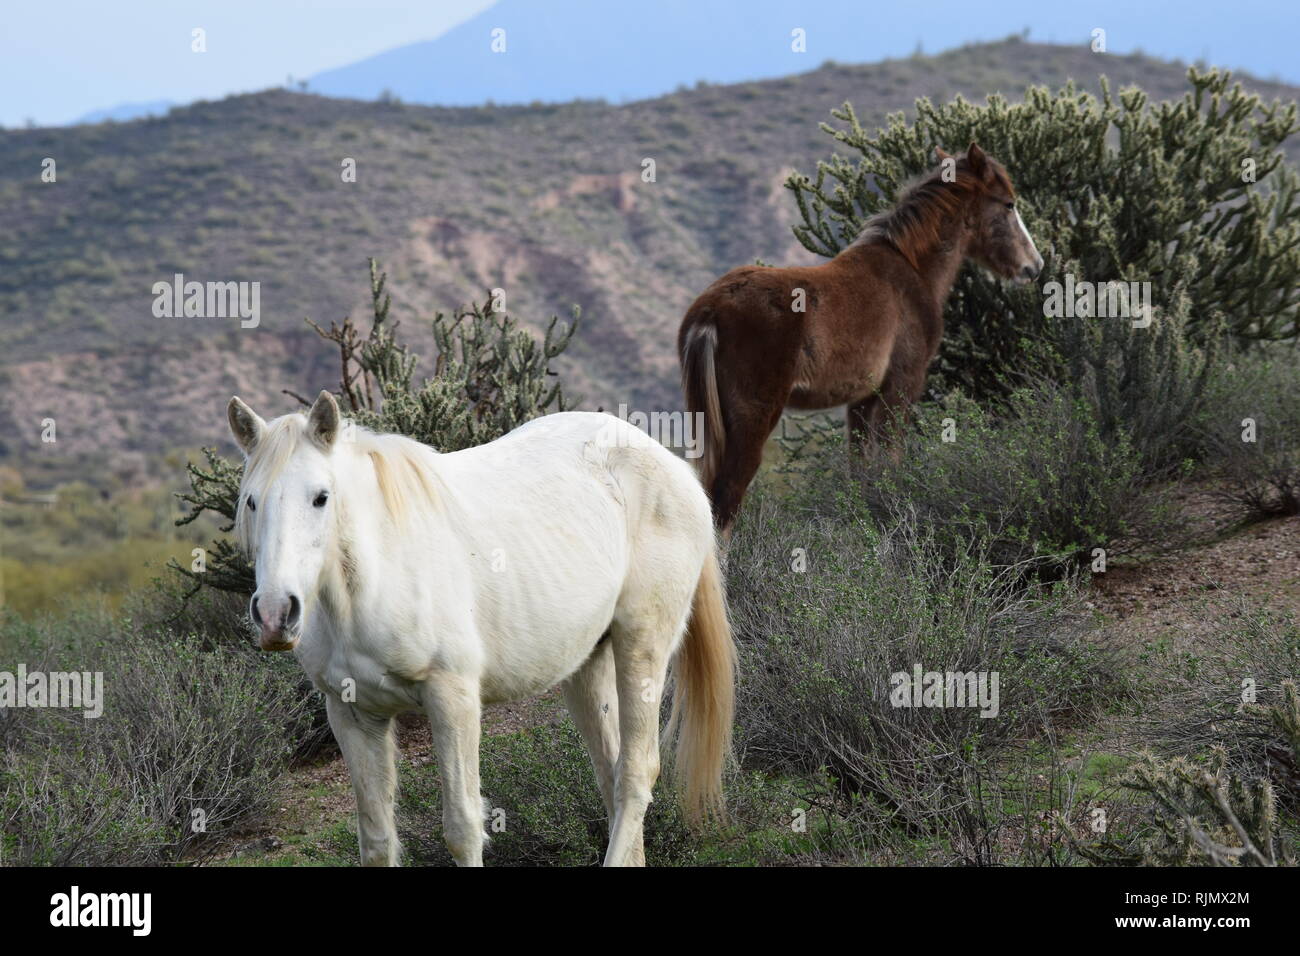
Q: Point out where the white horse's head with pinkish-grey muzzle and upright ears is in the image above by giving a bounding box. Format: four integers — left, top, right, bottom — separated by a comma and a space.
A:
226, 392, 339, 650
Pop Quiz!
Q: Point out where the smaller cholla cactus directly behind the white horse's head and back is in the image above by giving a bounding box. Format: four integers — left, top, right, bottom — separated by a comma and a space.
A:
170, 259, 579, 598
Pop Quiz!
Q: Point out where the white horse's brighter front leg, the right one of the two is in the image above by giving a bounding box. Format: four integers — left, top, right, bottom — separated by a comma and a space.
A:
424, 672, 484, 866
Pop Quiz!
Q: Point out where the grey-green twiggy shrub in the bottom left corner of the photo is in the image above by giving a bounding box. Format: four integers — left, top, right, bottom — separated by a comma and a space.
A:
0, 615, 309, 866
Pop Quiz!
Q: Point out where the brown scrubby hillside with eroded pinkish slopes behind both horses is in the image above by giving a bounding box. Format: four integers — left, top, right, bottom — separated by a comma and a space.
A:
0, 40, 1297, 485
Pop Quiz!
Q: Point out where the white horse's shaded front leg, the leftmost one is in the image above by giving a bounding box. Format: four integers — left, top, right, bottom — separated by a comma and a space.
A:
325, 693, 399, 866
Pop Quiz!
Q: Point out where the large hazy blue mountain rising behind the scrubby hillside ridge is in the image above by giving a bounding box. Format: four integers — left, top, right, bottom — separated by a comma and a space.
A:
311, 0, 1300, 105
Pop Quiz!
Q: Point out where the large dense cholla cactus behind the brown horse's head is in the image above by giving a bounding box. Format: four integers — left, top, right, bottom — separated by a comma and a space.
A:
785, 69, 1300, 397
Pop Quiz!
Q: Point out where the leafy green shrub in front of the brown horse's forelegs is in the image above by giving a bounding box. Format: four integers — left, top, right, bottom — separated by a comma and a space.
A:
787, 382, 1175, 574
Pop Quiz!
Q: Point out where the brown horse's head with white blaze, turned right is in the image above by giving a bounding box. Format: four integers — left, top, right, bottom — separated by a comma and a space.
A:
936, 143, 1043, 282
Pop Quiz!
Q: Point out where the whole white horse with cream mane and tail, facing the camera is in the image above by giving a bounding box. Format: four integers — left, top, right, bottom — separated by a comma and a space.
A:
228, 392, 735, 866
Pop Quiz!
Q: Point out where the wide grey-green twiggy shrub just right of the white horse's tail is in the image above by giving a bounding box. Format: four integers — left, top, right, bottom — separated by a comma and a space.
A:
728, 489, 1122, 862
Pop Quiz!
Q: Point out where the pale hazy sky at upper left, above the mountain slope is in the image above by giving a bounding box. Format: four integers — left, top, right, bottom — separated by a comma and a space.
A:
0, 0, 493, 126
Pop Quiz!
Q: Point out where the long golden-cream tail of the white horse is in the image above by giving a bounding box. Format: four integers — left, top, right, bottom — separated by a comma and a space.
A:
668, 549, 736, 823
